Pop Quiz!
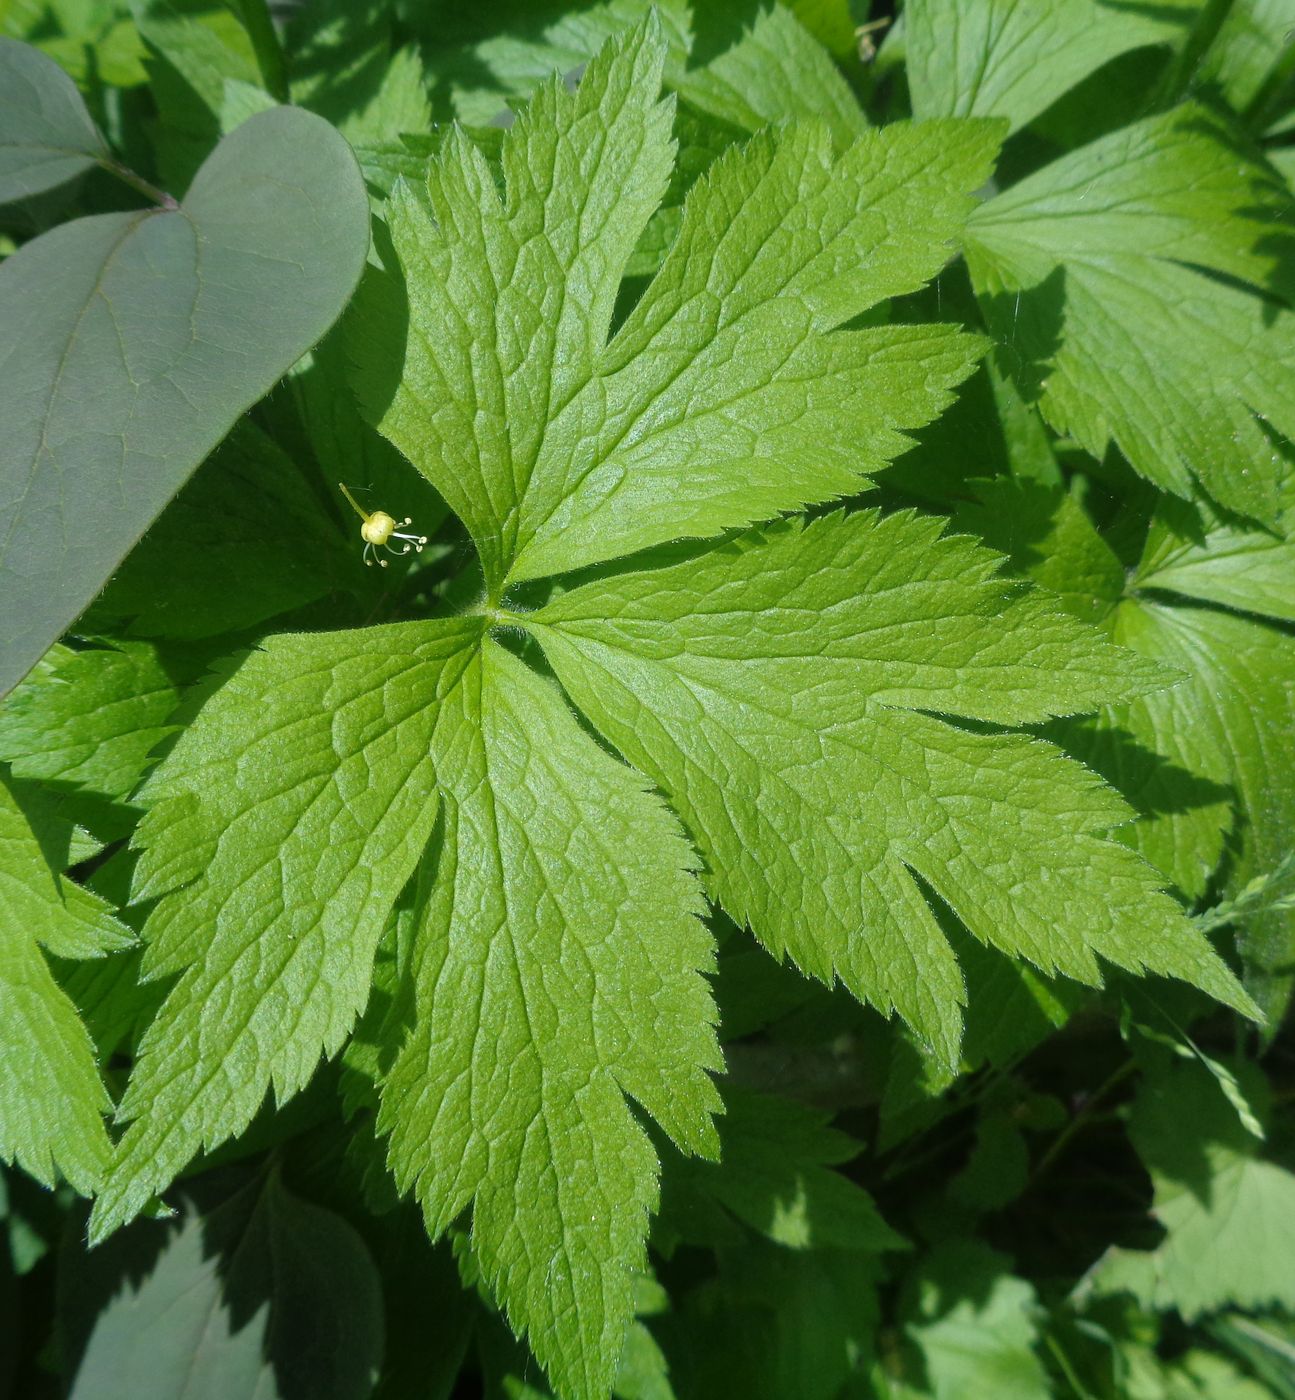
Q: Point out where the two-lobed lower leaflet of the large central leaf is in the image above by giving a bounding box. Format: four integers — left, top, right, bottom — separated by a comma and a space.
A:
91, 620, 720, 1394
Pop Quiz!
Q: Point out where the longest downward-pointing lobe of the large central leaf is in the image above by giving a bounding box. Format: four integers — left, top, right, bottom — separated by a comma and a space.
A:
378, 640, 721, 1397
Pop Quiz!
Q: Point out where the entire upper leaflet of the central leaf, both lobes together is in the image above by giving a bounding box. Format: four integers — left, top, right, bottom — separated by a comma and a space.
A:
353, 20, 995, 595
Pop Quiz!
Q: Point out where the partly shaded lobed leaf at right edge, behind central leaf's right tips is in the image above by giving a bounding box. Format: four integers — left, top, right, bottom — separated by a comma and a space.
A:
958, 482, 1295, 1013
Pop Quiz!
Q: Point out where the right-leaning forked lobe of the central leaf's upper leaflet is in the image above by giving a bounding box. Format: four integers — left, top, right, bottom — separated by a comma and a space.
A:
510, 122, 998, 580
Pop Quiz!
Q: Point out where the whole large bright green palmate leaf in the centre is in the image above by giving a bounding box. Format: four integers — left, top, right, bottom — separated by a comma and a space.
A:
91, 21, 1252, 1400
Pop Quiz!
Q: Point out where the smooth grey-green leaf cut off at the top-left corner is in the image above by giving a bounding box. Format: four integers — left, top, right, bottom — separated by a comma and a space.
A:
0, 38, 109, 204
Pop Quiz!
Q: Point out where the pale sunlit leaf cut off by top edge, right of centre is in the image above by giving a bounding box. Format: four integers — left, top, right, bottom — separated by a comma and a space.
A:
904, 0, 1177, 130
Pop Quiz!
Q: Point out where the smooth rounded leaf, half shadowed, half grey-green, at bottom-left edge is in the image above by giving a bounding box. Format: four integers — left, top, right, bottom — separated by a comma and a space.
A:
62, 1173, 382, 1400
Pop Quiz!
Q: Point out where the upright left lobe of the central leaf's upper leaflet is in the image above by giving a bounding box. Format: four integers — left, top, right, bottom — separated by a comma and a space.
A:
357, 24, 673, 584
